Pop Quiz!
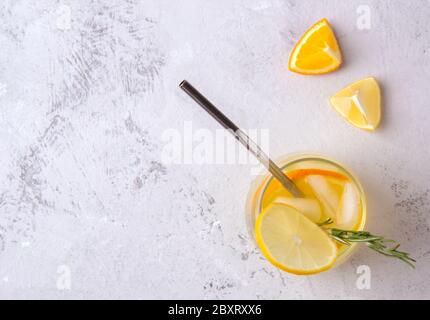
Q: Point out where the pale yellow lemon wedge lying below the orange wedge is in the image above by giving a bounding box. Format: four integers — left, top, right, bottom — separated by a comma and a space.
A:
330, 77, 381, 130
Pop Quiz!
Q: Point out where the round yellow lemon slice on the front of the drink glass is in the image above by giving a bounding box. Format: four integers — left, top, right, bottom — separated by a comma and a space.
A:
255, 204, 337, 275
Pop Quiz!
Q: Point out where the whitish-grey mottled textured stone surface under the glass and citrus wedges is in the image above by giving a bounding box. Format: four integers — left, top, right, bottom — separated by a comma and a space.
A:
0, 0, 430, 299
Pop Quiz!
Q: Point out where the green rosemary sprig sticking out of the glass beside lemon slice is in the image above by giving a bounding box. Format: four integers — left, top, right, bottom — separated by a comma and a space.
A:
318, 218, 416, 268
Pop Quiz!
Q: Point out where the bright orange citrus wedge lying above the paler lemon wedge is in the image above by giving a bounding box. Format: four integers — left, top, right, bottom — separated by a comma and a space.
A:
289, 19, 342, 74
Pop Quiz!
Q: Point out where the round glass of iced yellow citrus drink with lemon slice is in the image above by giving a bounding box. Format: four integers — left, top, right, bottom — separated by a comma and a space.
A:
246, 154, 367, 274
